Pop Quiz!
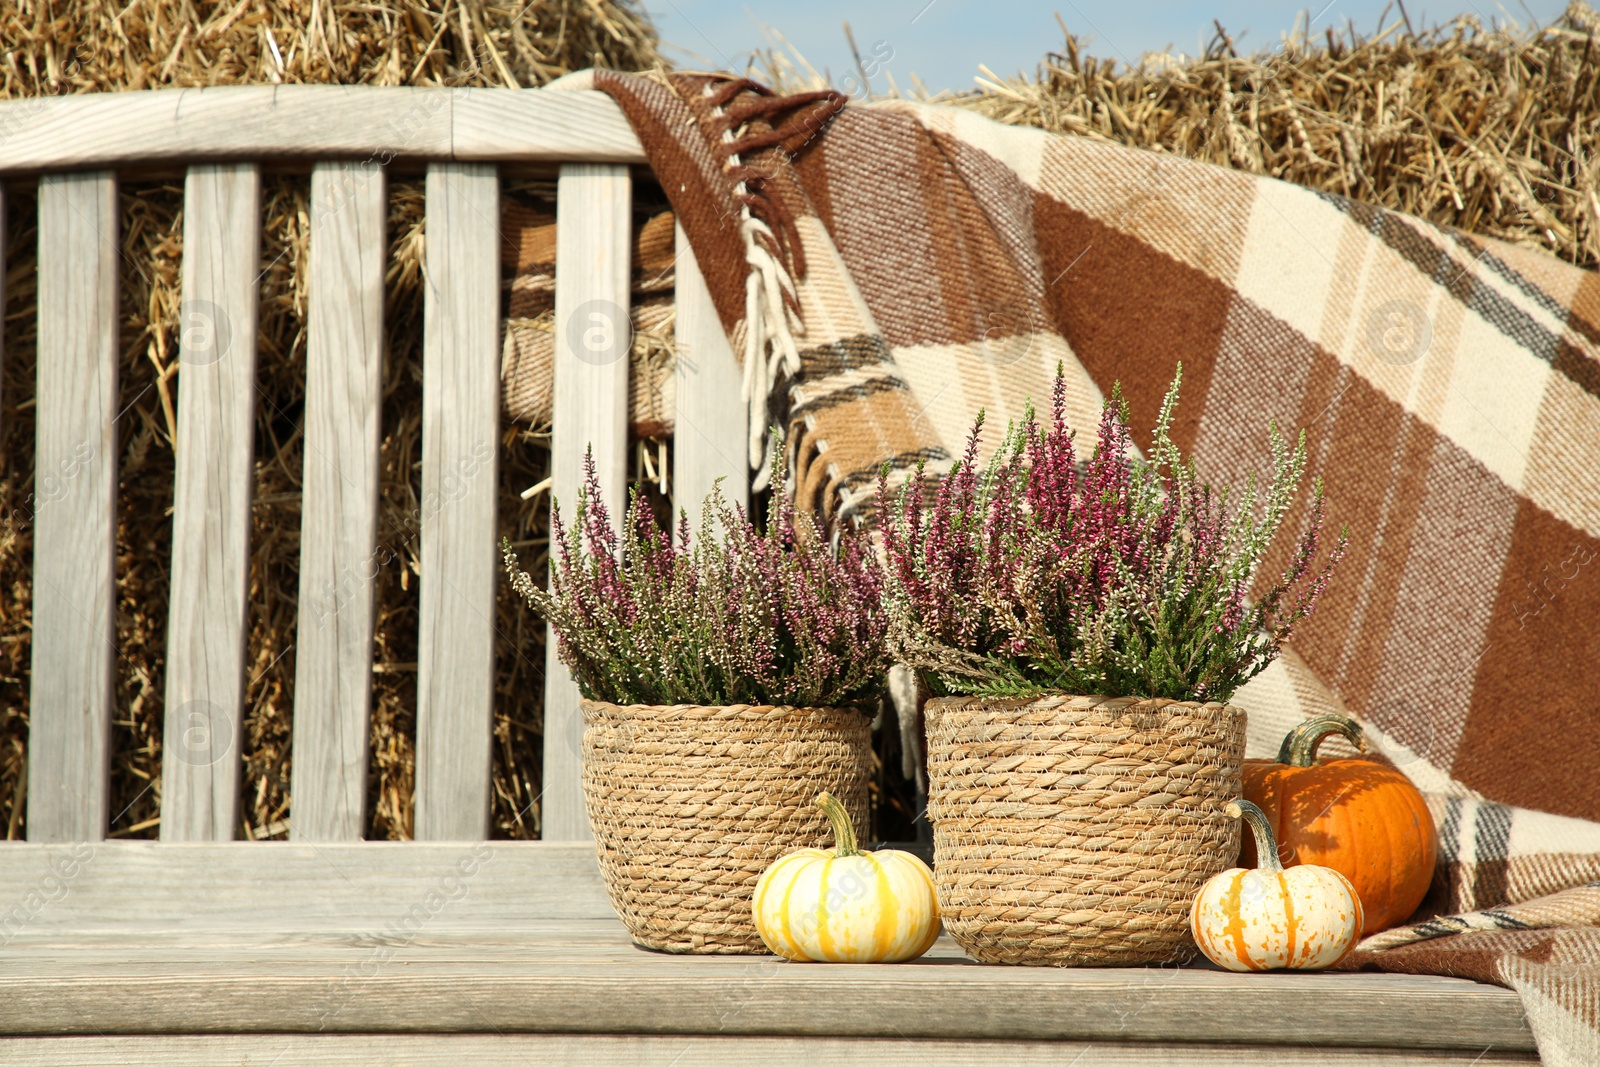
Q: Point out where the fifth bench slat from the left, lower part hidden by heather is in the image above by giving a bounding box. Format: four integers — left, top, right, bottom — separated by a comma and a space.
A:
539, 163, 632, 841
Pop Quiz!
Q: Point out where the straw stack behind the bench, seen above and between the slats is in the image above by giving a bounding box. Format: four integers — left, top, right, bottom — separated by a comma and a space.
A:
0, 0, 659, 838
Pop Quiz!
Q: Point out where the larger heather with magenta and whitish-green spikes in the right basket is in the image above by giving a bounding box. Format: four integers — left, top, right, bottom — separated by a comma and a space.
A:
878, 365, 1346, 701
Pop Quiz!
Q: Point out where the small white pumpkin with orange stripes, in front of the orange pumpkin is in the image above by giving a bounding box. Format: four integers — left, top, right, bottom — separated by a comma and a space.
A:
1189, 800, 1362, 971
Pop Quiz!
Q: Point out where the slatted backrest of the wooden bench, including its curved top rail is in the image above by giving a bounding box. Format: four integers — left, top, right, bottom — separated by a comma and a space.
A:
0, 86, 747, 843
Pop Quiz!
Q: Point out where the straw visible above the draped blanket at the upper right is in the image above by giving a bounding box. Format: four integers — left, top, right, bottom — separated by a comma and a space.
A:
949, 2, 1600, 269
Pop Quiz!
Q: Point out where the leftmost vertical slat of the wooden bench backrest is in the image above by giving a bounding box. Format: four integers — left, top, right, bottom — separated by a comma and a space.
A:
27, 173, 117, 841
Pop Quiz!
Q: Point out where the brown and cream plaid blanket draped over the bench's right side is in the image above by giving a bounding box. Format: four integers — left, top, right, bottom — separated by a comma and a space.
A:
540, 72, 1600, 1062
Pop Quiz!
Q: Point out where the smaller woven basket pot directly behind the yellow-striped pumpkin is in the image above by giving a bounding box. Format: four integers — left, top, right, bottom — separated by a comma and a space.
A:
582, 701, 872, 955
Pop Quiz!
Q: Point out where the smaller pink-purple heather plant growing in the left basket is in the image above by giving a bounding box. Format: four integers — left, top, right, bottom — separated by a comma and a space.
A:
501, 448, 888, 707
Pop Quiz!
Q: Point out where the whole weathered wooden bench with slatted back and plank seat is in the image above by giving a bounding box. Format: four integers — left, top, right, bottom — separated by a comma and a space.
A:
0, 86, 1536, 1067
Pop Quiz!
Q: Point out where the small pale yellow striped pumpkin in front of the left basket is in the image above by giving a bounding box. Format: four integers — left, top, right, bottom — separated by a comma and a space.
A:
750, 793, 939, 963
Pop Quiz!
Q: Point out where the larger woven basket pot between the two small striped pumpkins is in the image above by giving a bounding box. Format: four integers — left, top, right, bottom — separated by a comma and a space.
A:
928, 696, 1245, 966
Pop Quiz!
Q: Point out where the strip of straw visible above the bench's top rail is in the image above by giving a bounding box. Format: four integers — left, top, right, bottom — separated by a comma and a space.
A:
0, 0, 658, 98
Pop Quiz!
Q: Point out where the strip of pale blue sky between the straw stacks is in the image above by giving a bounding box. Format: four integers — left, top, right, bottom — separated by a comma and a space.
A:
645, 0, 1566, 91
